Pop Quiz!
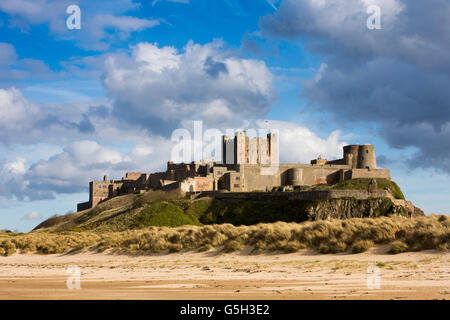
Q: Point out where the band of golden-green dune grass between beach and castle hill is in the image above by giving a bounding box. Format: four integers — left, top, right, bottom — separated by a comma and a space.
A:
0, 215, 450, 255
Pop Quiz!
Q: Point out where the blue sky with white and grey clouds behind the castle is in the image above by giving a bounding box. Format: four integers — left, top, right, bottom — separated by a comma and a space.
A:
0, 0, 450, 231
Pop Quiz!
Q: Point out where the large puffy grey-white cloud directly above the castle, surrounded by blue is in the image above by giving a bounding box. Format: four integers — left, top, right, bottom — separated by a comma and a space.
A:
103, 41, 276, 135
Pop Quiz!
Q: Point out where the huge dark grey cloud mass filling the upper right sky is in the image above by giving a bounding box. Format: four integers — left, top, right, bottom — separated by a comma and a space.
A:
261, 0, 450, 173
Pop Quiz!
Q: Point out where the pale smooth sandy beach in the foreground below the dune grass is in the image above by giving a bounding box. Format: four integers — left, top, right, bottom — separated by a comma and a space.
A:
0, 247, 450, 300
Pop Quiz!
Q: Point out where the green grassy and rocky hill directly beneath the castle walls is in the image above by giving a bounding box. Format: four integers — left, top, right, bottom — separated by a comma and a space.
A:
35, 179, 407, 232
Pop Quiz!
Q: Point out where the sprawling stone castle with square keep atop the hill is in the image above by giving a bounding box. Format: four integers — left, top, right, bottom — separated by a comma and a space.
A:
77, 131, 390, 211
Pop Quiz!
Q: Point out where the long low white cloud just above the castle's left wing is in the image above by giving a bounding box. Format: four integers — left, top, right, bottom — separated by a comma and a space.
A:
21, 138, 171, 195
